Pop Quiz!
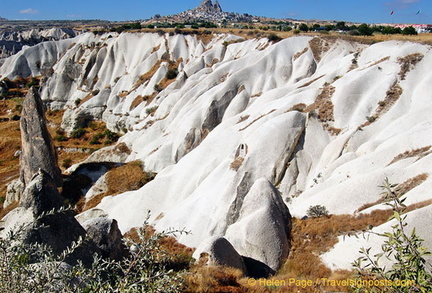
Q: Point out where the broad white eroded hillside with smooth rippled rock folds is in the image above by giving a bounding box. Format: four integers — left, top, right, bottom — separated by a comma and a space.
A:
0, 33, 432, 269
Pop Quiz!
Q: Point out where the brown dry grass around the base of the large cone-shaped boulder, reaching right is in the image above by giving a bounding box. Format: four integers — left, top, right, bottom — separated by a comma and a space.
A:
186, 210, 392, 293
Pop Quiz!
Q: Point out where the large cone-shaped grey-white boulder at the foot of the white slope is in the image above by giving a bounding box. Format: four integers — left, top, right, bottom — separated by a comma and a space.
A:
225, 178, 291, 271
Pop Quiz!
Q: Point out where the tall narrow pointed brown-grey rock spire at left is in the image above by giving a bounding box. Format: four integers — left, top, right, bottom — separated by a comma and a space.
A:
20, 87, 62, 187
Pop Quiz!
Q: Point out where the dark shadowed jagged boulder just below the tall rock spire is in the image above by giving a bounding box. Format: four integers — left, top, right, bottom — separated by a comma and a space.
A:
0, 170, 100, 265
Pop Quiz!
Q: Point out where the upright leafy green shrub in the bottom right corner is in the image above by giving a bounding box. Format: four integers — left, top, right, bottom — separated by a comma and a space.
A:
353, 178, 432, 292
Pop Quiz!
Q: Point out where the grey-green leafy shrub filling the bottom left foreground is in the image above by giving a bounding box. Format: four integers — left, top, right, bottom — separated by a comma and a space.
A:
0, 213, 190, 293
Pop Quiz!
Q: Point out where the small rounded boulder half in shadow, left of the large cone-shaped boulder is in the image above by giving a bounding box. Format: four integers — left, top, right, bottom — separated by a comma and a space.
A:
193, 236, 247, 274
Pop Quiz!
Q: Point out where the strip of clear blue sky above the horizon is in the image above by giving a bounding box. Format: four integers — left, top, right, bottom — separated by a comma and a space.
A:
0, 0, 432, 23
